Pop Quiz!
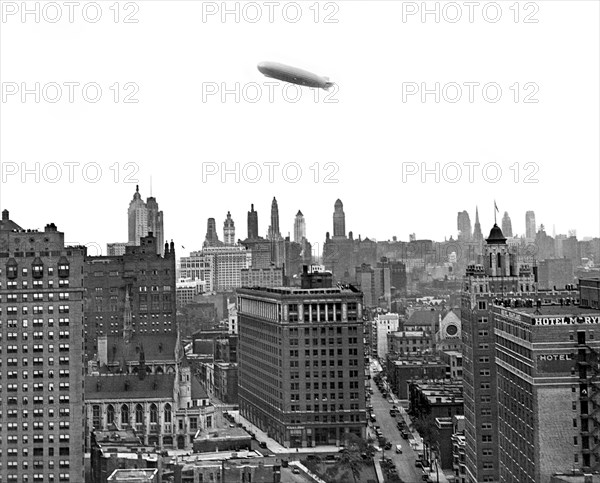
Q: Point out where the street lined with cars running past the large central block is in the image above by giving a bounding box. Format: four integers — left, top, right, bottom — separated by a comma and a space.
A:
369, 385, 423, 483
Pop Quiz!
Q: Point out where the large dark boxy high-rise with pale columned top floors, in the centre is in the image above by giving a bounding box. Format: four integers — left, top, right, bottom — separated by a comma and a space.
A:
237, 273, 366, 447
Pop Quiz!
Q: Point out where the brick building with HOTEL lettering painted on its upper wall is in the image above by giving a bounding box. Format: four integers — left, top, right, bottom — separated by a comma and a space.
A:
493, 290, 600, 483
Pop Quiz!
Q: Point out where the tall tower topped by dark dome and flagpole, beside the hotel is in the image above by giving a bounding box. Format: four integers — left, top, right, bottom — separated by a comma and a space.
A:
461, 225, 536, 482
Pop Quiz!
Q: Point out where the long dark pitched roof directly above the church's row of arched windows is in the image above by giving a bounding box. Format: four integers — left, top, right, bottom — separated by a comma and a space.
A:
85, 374, 175, 400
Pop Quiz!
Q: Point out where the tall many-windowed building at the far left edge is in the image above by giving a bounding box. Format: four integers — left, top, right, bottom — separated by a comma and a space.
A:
0, 210, 86, 483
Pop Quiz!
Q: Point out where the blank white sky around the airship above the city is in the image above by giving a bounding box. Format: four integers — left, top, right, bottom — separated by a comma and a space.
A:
0, 0, 600, 254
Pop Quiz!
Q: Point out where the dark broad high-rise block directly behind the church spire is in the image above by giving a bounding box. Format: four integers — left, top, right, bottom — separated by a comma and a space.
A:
84, 235, 176, 360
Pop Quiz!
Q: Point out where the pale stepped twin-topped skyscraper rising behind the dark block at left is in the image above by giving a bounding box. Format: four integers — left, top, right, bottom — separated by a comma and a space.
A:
127, 186, 164, 255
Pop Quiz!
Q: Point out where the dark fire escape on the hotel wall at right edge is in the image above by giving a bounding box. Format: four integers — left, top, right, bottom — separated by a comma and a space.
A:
577, 332, 600, 472
